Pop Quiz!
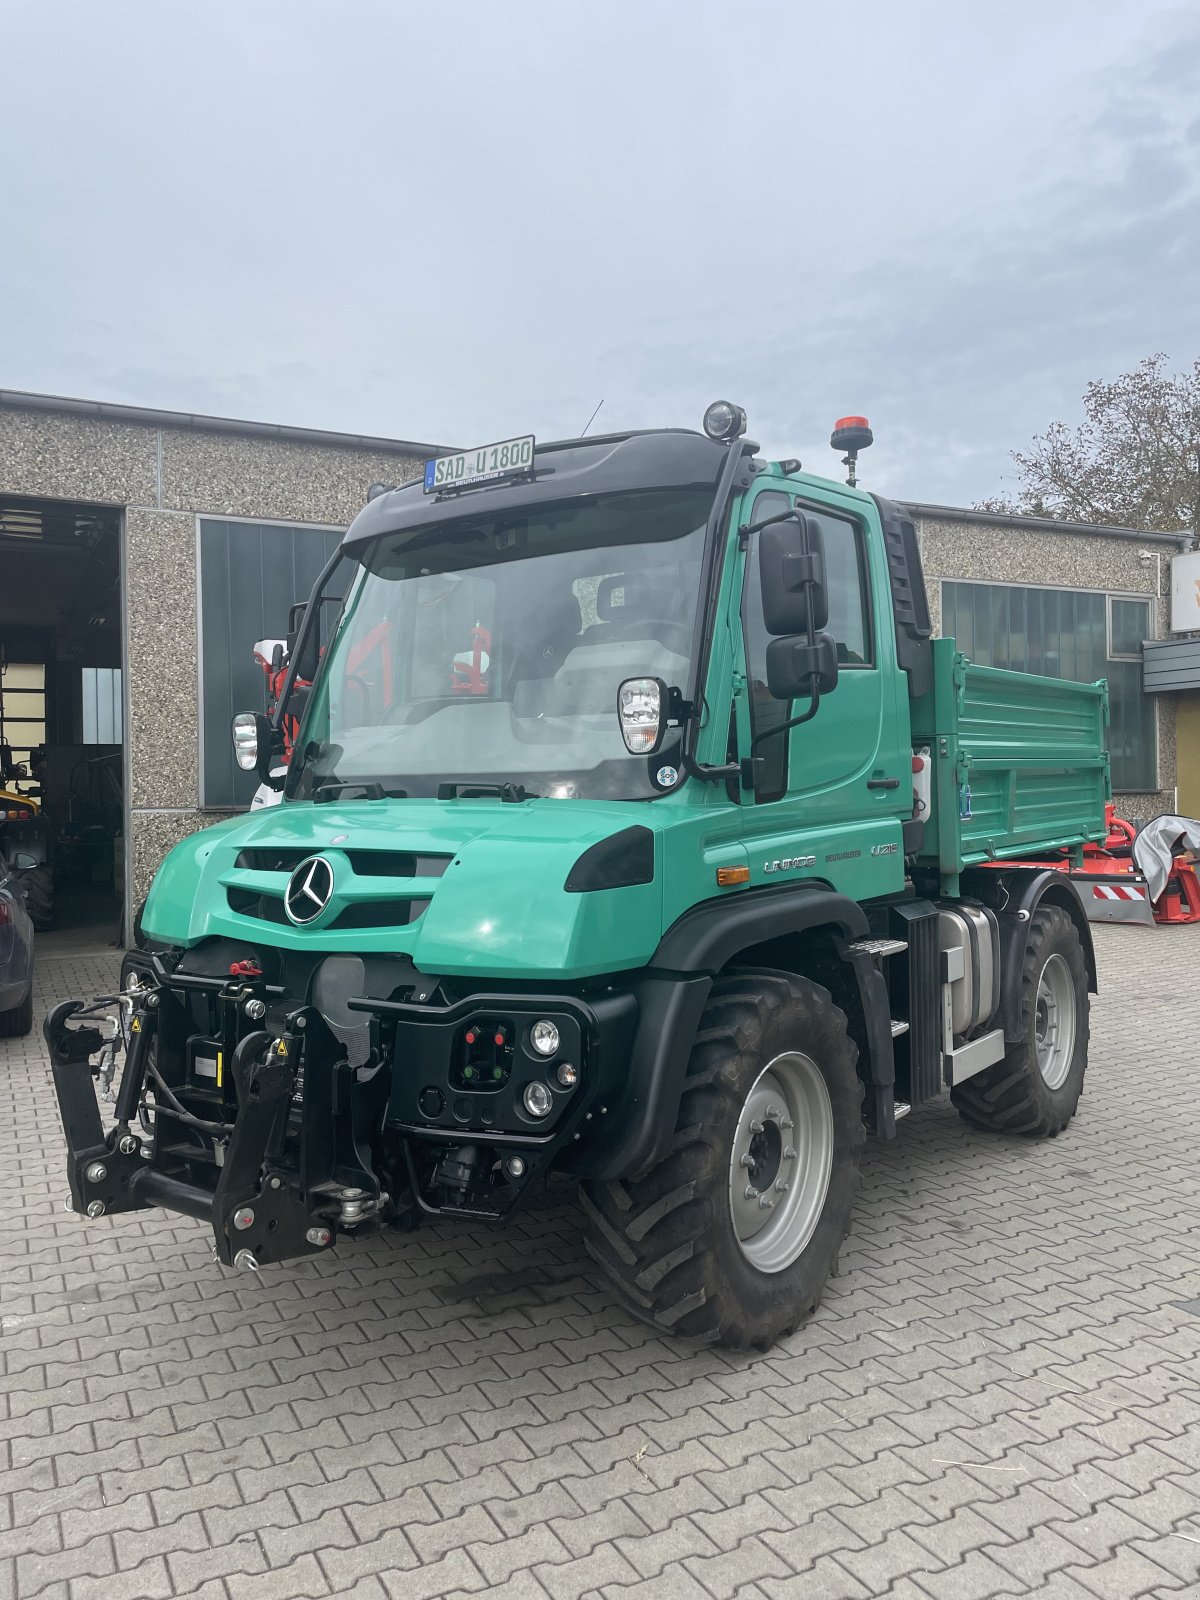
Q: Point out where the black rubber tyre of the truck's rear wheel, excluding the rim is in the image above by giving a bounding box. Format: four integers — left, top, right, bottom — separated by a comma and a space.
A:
950, 906, 1088, 1139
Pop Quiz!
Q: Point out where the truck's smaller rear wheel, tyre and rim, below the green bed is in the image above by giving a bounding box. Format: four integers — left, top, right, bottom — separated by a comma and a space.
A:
950, 906, 1090, 1139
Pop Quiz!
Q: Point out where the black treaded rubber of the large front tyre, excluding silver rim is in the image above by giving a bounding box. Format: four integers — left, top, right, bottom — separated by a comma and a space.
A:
581, 971, 866, 1349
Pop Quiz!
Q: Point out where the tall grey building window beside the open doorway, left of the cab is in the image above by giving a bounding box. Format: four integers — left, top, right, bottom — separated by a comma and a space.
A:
198, 517, 341, 810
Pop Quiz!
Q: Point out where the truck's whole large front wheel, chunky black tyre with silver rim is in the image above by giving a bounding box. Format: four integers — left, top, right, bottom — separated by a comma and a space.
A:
584, 971, 866, 1349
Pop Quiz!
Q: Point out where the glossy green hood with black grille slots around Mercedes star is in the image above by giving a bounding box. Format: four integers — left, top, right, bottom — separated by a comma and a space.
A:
142, 798, 667, 979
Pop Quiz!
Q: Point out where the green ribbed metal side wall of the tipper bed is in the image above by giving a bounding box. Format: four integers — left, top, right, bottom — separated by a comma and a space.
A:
912, 638, 1112, 894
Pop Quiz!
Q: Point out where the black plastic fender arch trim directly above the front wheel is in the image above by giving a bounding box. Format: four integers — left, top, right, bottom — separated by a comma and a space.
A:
650, 883, 870, 973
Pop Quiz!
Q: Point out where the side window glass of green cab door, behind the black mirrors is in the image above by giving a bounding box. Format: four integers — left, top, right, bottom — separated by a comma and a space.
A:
742, 490, 875, 802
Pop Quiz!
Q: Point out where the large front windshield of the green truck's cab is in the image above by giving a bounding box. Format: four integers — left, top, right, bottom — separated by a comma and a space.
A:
288, 488, 712, 798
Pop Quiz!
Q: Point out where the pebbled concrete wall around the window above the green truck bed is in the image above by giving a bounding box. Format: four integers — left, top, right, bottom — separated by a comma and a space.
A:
917, 517, 1178, 821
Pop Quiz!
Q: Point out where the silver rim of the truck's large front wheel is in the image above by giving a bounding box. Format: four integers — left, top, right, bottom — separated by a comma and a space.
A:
730, 1050, 834, 1272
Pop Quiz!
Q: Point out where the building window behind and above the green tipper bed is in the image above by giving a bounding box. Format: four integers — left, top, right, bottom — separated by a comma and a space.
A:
942, 581, 1158, 792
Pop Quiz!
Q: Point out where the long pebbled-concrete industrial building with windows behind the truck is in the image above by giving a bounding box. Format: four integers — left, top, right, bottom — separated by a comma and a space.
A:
0, 390, 1200, 928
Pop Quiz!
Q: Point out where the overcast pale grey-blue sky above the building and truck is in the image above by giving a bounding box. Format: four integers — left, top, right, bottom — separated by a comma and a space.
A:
0, 0, 1200, 504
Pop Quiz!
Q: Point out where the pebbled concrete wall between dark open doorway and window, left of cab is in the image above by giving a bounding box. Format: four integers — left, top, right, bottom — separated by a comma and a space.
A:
0, 405, 422, 904
